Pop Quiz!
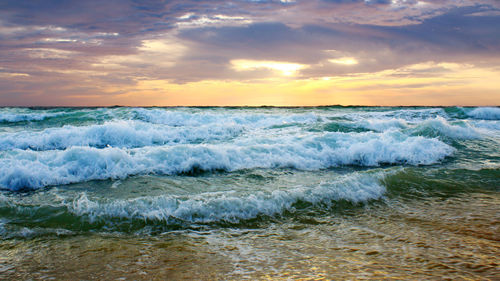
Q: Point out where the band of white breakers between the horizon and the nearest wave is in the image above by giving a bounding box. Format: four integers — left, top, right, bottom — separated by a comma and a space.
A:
0, 107, 500, 190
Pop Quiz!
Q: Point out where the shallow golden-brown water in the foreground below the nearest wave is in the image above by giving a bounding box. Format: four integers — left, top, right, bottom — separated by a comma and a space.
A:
0, 192, 500, 280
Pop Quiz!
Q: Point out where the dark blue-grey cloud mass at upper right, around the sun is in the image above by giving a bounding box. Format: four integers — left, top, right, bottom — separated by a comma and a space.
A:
171, 6, 500, 78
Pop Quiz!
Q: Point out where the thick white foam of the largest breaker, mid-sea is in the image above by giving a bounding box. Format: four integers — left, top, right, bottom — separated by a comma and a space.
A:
0, 132, 454, 190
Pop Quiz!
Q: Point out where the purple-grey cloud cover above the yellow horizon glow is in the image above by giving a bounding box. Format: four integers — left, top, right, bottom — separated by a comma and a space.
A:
0, 0, 500, 104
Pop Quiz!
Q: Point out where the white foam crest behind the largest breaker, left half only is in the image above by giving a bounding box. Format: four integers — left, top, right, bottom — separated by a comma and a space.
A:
0, 120, 243, 150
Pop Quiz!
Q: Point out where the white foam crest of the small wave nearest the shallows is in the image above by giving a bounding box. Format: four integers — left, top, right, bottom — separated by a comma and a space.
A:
68, 173, 385, 223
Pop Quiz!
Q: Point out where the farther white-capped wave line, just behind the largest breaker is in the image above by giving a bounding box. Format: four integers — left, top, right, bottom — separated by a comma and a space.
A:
0, 118, 484, 151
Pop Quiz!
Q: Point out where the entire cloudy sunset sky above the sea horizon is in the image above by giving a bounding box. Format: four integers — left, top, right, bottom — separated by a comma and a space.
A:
0, 0, 500, 106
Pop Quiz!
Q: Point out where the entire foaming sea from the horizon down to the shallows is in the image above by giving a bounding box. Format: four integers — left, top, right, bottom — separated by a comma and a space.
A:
0, 106, 500, 280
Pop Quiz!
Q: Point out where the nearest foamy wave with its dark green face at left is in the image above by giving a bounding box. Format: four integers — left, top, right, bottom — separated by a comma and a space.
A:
0, 171, 393, 236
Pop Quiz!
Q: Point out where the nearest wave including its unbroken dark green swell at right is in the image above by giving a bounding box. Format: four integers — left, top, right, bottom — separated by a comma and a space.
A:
0, 167, 500, 238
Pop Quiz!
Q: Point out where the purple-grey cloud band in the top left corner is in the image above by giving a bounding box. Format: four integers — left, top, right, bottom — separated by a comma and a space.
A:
0, 0, 175, 34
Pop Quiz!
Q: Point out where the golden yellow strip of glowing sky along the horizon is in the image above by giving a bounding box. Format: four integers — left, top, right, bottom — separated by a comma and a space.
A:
94, 62, 498, 106
